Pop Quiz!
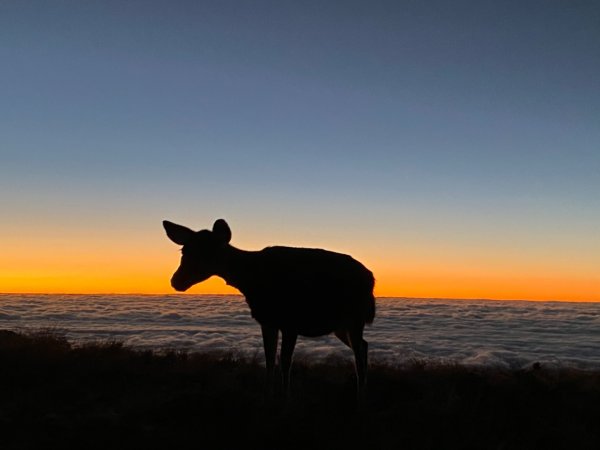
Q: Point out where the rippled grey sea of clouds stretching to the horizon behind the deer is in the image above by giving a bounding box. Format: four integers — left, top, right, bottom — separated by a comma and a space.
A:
0, 294, 600, 369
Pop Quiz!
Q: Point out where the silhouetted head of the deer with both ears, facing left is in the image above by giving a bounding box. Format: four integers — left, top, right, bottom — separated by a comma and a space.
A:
163, 219, 231, 291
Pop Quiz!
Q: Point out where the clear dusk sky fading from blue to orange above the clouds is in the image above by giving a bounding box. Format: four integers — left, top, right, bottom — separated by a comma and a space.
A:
0, 0, 600, 301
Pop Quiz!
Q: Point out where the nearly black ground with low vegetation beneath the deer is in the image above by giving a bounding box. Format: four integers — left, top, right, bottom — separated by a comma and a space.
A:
0, 331, 600, 450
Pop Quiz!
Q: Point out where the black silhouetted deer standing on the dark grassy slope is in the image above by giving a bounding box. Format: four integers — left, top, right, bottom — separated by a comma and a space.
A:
163, 219, 375, 397
